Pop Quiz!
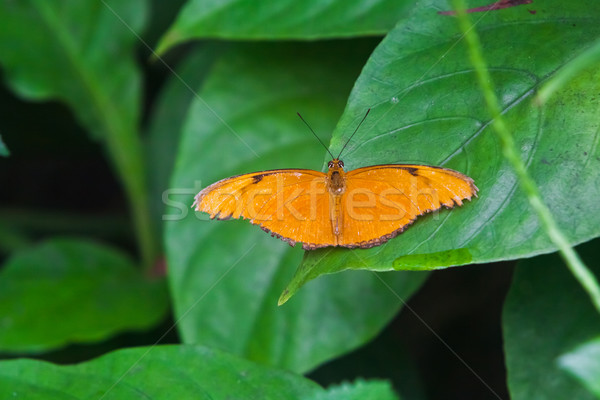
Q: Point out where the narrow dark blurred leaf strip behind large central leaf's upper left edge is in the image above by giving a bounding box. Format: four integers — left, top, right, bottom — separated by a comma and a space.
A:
146, 44, 221, 233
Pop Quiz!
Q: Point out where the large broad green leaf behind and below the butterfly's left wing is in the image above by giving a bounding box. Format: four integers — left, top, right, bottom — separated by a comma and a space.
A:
165, 41, 427, 371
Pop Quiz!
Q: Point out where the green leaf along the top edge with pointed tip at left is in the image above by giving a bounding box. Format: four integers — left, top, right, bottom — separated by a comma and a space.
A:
157, 0, 414, 54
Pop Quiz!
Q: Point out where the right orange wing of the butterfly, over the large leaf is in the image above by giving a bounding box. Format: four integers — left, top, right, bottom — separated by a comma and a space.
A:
339, 164, 477, 247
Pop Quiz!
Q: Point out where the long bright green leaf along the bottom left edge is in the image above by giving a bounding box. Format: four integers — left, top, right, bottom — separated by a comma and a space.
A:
0, 346, 323, 400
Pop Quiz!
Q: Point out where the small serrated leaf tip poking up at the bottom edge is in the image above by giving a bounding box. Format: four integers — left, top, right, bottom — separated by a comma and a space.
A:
303, 380, 399, 400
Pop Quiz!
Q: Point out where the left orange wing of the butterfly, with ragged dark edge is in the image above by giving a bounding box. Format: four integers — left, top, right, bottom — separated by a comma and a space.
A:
194, 169, 336, 249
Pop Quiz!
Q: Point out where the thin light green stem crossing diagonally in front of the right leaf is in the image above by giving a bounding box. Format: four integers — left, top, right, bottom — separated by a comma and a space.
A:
454, 0, 600, 312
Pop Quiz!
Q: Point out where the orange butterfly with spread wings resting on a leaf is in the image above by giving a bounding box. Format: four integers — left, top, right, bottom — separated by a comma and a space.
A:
192, 111, 478, 250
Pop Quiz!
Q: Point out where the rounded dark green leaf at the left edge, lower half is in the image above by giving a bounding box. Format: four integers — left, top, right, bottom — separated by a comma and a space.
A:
0, 238, 168, 353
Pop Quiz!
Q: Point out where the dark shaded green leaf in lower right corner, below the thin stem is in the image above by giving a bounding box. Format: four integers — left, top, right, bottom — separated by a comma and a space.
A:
503, 240, 600, 400
